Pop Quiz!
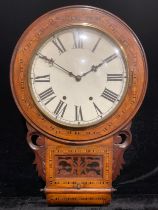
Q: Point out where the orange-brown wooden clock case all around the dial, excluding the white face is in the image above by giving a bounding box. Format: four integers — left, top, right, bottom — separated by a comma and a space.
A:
11, 6, 147, 205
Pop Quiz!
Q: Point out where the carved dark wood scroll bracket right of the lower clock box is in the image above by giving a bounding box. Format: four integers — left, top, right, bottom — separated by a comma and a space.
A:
113, 122, 132, 181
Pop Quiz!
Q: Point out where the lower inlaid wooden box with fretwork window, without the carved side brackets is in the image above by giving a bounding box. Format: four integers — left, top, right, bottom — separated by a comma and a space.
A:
44, 134, 113, 205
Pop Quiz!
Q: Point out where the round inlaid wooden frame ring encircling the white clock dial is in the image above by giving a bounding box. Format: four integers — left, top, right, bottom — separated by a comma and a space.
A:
10, 6, 147, 142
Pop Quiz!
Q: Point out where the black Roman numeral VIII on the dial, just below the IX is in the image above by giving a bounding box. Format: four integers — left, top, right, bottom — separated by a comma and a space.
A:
39, 88, 56, 105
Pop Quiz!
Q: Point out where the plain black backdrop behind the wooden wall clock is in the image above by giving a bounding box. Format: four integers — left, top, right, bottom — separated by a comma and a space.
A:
0, 0, 158, 196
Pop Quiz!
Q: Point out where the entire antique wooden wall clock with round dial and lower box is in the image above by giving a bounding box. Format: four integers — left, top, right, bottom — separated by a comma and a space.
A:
11, 6, 147, 205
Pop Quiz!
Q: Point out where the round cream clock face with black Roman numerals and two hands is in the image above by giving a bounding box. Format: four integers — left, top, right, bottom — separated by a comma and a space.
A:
28, 26, 128, 127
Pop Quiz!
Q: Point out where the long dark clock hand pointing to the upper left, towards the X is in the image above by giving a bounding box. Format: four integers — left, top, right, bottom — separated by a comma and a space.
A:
37, 53, 77, 79
